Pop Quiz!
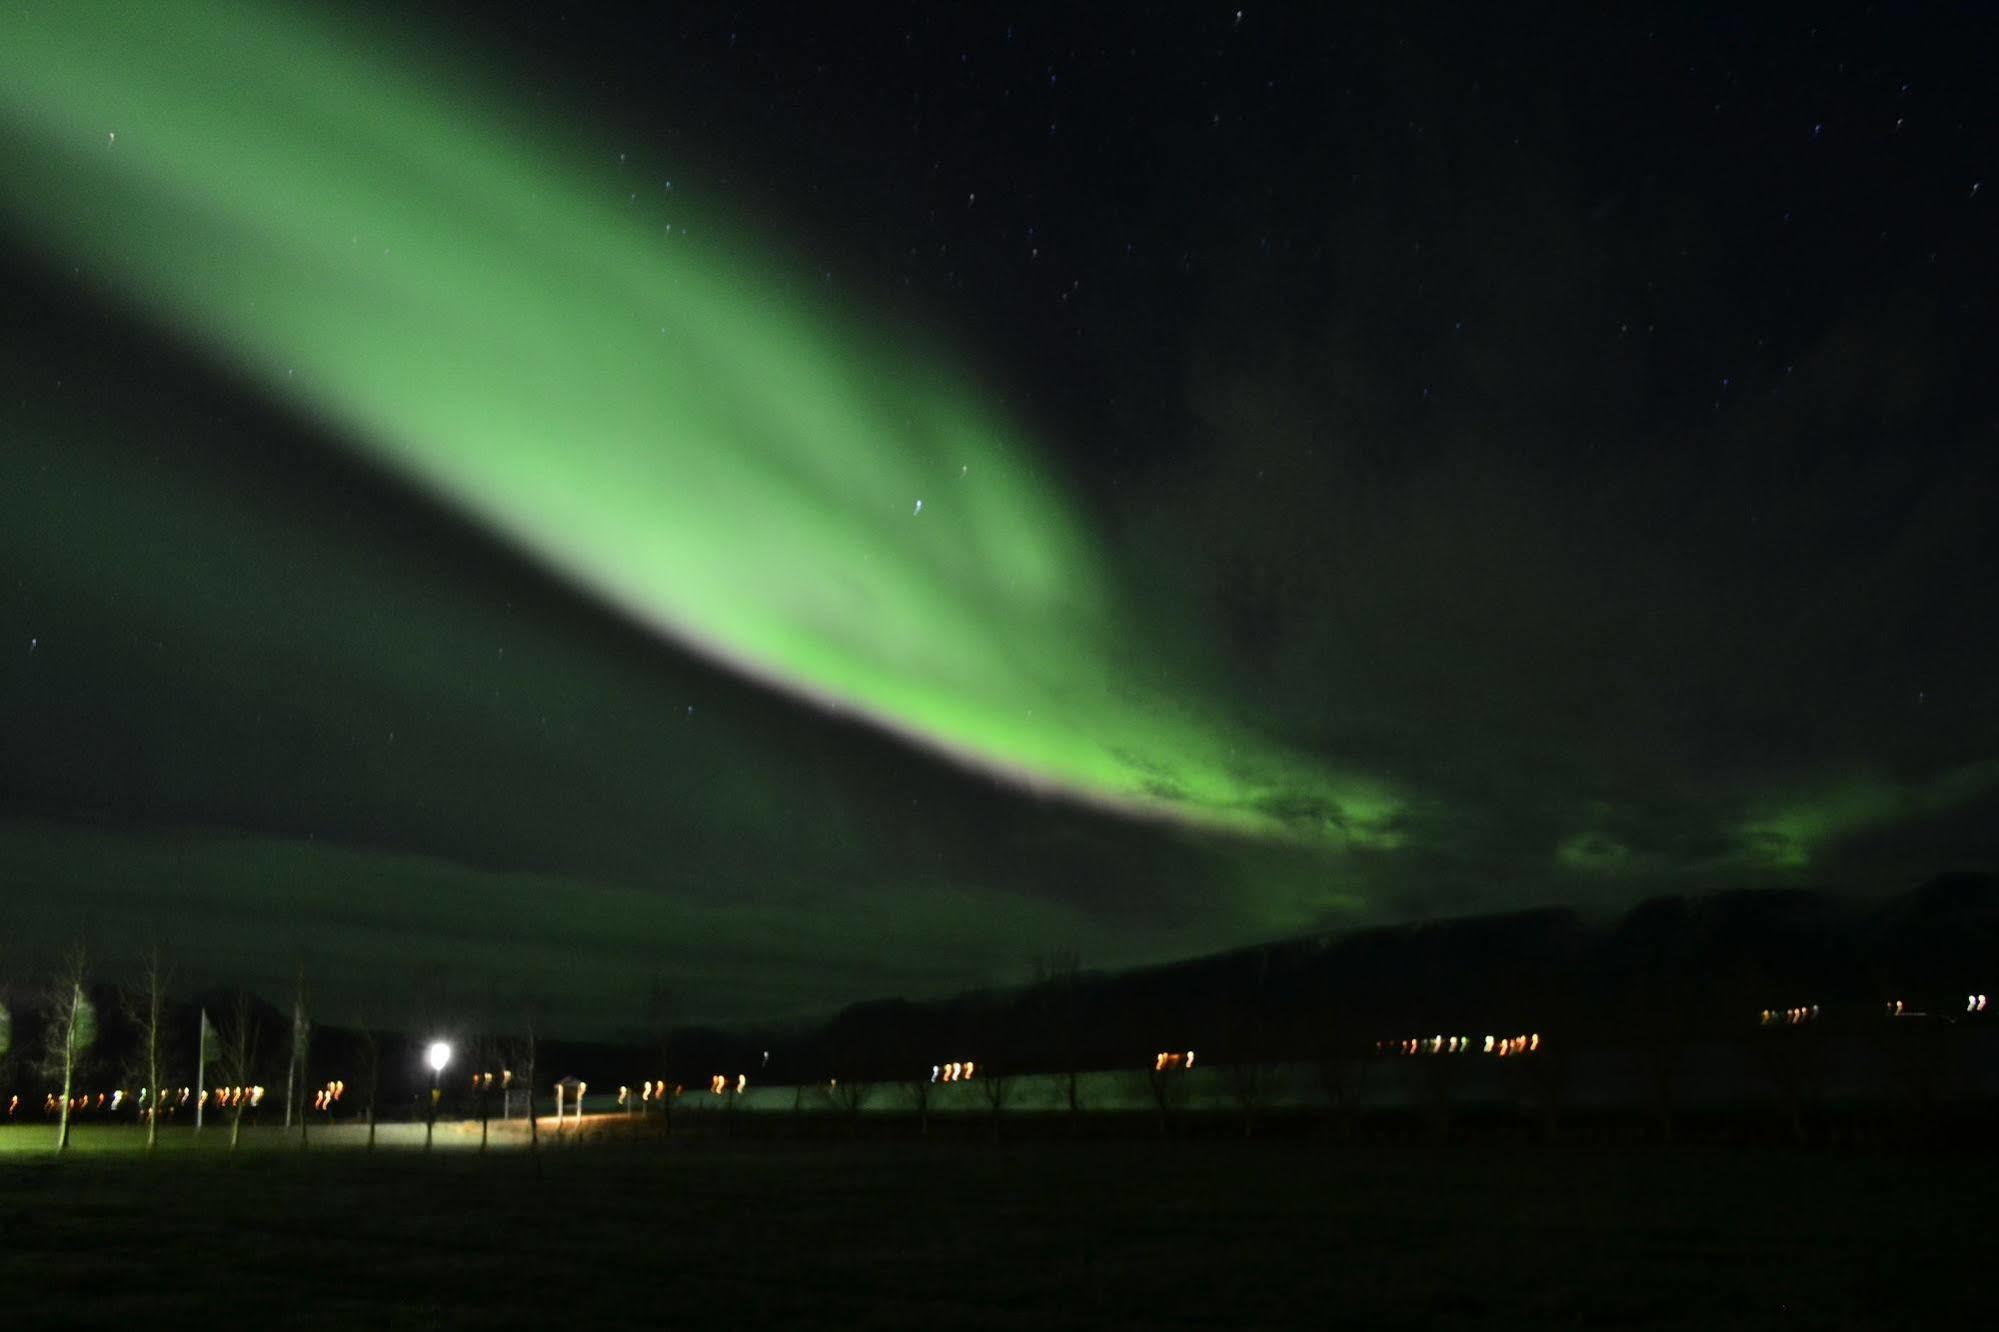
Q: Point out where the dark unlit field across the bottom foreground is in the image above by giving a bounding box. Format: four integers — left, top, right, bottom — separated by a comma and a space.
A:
0, 1138, 1999, 1332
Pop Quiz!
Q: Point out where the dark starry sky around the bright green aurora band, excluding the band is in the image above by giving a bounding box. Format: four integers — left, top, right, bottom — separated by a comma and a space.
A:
0, 4, 1999, 1030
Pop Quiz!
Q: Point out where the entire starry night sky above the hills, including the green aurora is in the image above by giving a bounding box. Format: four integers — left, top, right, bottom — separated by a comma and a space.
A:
0, 2, 1999, 1034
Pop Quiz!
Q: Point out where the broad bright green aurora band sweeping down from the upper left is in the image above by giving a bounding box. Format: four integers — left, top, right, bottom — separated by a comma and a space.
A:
0, 0, 1403, 848
